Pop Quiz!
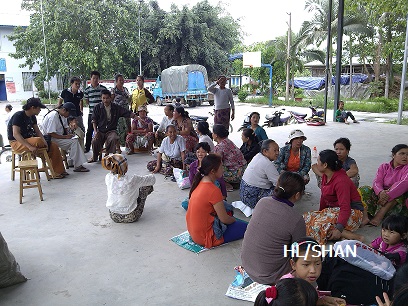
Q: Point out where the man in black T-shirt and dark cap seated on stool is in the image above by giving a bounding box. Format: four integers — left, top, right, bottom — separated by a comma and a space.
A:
7, 98, 65, 178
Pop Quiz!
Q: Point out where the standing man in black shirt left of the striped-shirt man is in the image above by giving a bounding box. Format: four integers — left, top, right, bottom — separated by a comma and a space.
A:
58, 77, 85, 132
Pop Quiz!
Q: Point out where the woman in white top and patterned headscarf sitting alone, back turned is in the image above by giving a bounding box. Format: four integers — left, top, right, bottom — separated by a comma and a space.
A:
102, 154, 156, 223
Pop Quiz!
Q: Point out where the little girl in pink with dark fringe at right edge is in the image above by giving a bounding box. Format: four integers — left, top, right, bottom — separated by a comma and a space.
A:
371, 215, 408, 266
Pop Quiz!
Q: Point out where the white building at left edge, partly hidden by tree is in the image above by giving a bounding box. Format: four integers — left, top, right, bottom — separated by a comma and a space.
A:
0, 12, 62, 101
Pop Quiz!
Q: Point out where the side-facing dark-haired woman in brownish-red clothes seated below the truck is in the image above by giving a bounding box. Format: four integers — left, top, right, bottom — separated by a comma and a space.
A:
172, 106, 198, 152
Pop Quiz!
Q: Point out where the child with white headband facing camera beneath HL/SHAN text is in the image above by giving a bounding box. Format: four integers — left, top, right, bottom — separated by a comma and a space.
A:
281, 237, 346, 305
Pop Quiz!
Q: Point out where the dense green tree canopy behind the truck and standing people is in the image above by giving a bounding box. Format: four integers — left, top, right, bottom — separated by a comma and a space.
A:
9, 0, 241, 87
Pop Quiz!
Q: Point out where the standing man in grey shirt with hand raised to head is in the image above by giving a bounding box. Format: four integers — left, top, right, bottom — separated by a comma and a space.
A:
207, 75, 235, 130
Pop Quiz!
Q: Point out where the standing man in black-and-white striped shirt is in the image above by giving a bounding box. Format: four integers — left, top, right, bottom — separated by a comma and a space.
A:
84, 71, 107, 153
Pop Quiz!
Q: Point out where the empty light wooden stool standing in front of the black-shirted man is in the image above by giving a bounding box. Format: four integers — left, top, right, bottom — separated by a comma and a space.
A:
18, 160, 43, 204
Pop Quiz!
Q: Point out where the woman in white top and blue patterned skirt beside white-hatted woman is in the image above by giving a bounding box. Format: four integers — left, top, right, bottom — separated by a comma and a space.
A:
239, 139, 279, 208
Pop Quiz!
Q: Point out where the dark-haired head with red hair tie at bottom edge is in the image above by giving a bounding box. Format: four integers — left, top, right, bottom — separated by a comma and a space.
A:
254, 278, 317, 306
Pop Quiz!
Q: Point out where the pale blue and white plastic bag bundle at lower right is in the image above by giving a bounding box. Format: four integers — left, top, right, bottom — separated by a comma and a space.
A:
334, 240, 395, 280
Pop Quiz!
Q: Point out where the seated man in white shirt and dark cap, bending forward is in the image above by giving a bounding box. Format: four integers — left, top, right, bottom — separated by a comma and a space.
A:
42, 102, 89, 172
